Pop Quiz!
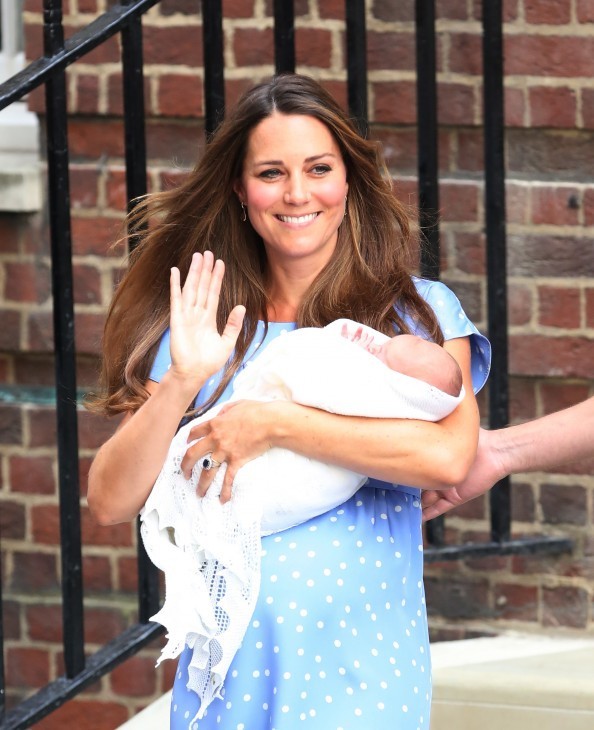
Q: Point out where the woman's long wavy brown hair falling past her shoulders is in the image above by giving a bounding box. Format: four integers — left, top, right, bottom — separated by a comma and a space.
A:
90, 74, 443, 415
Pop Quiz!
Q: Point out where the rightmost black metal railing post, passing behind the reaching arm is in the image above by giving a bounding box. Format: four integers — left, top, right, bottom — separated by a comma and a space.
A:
483, 0, 511, 542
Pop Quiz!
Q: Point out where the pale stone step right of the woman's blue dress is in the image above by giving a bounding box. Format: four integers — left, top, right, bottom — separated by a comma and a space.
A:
431, 634, 594, 730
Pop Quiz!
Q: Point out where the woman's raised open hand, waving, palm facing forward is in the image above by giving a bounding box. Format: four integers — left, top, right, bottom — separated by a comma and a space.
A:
170, 251, 245, 387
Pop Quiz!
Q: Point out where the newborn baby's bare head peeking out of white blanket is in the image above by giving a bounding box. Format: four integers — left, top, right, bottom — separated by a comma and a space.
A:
376, 335, 462, 397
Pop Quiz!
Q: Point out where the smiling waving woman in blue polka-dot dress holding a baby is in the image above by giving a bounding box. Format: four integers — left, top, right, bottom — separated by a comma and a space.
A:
89, 75, 488, 730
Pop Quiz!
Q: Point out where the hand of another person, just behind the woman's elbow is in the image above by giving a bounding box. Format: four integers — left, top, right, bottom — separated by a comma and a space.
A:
421, 428, 506, 522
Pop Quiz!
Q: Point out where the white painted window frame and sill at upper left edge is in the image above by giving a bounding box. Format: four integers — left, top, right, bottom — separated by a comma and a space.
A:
0, 0, 42, 213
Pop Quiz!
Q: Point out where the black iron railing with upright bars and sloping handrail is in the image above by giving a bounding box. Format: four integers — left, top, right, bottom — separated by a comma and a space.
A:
0, 0, 571, 730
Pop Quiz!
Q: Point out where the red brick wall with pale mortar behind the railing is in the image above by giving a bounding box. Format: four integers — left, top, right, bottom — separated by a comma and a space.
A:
0, 0, 594, 729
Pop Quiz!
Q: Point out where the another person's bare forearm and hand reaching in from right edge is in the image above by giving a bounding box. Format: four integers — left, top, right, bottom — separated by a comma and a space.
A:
423, 398, 594, 520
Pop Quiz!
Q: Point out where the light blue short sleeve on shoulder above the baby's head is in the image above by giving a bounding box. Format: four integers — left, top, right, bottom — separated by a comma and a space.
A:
414, 278, 491, 393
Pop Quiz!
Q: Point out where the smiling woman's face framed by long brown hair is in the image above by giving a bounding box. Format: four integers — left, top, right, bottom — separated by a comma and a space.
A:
235, 112, 348, 273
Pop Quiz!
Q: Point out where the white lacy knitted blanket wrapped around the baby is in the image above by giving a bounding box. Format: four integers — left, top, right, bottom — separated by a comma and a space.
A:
140, 320, 464, 718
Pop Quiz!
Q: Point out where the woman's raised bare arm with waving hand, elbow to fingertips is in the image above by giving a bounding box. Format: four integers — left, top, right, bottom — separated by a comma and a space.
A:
88, 252, 245, 524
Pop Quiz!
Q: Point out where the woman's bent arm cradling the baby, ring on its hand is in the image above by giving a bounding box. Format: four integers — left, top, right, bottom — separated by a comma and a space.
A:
182, 337, 479, 500
